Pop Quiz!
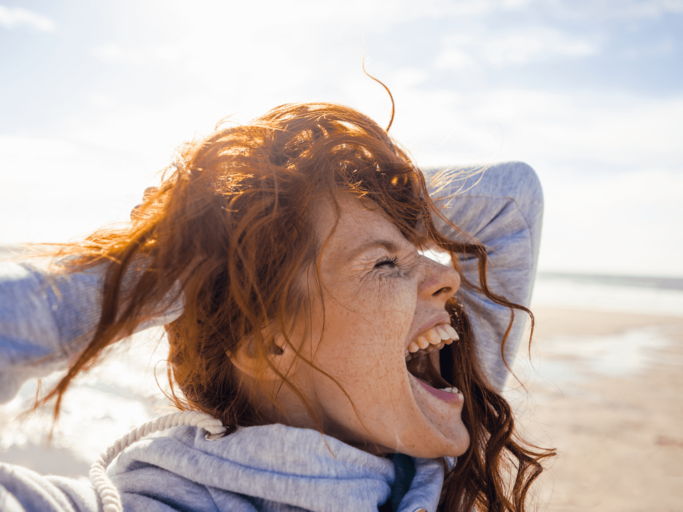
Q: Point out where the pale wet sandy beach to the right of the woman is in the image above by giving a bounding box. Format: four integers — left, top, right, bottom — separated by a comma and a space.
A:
508, 307, 683, 512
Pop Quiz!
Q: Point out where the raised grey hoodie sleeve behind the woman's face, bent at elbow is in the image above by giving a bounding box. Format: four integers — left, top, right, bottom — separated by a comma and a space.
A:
425, 162, 543, 390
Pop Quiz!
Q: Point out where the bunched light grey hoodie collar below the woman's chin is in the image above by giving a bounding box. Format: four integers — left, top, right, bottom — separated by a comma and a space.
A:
110, 424, 444, 512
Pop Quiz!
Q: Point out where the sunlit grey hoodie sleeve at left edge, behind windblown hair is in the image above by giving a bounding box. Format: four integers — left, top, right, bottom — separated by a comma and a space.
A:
0, 261, 183, 403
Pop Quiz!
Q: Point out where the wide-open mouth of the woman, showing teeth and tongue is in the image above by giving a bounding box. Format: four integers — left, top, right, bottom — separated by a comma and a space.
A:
406, 324, 463, 402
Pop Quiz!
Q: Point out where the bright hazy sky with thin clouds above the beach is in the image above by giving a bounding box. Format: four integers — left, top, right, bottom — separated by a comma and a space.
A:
0, 0, 683, 277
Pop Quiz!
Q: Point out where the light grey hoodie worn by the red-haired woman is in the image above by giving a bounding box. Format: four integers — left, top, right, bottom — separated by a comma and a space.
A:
0, 162, 543, 512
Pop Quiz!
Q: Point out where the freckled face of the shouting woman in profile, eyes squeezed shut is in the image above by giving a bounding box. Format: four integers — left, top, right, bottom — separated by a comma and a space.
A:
282, 193, 469, 458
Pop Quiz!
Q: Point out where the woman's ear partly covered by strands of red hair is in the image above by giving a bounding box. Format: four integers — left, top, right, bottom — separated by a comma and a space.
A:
228, 328, 297, 380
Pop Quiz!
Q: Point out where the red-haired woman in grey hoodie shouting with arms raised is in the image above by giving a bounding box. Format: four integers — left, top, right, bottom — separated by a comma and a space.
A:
0, 104, 551, 512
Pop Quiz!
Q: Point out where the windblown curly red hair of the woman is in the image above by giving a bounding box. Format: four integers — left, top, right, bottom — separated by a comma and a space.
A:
42, 103, 553, 512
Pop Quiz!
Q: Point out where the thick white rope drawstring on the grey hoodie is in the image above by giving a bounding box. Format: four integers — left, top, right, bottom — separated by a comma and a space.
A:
90, 411, 227, 512
